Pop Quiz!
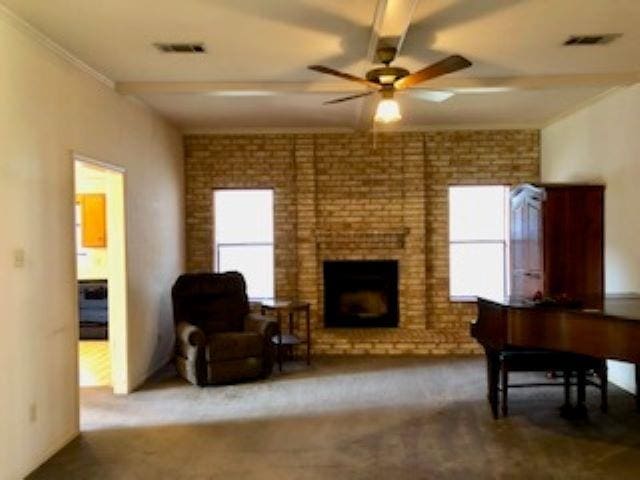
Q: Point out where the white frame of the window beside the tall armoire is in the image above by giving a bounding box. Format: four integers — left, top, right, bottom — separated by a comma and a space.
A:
447, 183, 511, 303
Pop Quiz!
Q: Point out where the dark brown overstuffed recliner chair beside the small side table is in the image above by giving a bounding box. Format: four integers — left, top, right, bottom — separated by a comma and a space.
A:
171, 272, 278, 386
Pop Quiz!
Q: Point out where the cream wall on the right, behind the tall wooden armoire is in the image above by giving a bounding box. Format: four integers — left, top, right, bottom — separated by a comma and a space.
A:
542, 85, 640, 390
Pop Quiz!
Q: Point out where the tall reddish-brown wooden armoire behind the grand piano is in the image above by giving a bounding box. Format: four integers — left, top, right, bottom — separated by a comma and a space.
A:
510, 184, 604, 309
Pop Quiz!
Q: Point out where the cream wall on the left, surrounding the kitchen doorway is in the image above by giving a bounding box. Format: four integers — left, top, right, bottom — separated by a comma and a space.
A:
0, 9, 184, 479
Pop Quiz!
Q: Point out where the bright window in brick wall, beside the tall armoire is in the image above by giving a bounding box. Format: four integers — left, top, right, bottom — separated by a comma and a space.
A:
449, 185, 509, 301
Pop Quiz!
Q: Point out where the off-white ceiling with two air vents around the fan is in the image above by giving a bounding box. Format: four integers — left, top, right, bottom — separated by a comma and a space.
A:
5, 0, 640, 130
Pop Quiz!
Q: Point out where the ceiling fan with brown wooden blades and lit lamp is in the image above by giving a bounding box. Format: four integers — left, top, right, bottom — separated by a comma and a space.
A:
309, 47, 471, 123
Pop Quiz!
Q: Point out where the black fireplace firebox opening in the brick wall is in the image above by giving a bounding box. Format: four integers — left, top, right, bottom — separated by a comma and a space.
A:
324, 260, 398, 328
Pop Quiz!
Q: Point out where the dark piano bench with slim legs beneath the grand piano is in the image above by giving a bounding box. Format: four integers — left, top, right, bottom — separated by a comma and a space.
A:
499, 349, 608, 417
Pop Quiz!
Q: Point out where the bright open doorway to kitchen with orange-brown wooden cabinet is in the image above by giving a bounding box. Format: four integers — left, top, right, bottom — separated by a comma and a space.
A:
74, 155, 129, 393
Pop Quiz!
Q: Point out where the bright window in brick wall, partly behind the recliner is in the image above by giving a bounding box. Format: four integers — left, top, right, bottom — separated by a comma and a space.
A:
213, 190, 274, 299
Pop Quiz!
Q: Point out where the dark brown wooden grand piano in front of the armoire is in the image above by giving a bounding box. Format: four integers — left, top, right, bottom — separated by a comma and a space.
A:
471, 295, 640, 417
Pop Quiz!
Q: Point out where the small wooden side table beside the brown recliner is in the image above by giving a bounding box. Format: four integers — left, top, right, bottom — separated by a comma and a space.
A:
261, 300, 311, 371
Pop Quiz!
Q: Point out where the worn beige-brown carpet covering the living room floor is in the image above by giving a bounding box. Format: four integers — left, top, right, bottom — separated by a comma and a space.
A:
32, 357, 640, 480
